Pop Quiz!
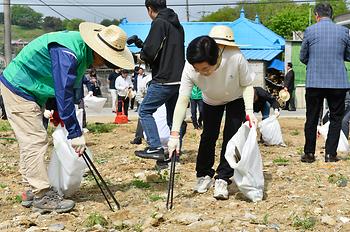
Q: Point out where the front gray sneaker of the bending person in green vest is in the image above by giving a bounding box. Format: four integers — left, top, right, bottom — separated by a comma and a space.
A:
33, 189, 75, 213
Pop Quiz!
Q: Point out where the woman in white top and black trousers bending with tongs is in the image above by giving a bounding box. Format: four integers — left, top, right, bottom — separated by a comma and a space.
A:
168, 26, 257, 200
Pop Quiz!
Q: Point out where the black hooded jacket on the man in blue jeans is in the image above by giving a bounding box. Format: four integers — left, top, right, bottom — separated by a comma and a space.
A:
140, 8, 185, 84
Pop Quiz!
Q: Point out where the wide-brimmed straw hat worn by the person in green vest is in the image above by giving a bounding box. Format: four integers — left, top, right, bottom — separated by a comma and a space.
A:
79, 22, 135, 69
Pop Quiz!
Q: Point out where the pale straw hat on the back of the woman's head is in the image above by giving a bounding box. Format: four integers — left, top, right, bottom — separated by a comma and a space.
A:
209, 25, 239, 47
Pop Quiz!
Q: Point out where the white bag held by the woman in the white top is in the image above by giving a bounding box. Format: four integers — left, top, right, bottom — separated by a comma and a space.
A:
225, 122, 264, 202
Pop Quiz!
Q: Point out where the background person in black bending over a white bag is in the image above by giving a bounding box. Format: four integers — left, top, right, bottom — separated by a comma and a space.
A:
253, 87, 280, 120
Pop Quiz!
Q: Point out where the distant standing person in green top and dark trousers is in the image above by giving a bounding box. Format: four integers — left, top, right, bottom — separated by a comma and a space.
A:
190, 85, 203, 130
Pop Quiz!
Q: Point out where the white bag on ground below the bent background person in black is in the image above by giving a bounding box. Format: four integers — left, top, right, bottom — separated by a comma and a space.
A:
259, 115, 286, 146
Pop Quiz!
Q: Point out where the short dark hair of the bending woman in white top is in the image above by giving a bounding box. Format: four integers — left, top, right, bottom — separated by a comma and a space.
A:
186, 35, 219, 65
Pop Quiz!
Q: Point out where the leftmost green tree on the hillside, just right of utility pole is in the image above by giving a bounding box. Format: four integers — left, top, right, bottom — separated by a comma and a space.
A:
11, 5, 43, 28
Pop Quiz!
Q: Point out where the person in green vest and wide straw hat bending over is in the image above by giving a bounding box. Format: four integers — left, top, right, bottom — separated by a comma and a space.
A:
0, 22, 134, 213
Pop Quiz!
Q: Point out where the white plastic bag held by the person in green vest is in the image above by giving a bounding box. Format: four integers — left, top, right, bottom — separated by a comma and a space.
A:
48, 125, 91, 196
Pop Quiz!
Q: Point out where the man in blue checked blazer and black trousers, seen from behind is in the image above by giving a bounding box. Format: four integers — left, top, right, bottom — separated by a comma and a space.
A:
300, 3, 350, 163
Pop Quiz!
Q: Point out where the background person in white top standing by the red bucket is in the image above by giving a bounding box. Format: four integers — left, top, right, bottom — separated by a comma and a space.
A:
115, 69, 133, 116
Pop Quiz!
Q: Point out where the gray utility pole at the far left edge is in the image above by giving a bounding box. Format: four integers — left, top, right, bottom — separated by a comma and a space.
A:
3, 0, 12, 66
